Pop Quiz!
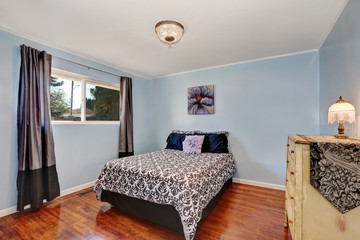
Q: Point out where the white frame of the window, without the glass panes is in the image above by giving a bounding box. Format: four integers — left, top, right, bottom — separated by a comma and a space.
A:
51, 68, 120, 125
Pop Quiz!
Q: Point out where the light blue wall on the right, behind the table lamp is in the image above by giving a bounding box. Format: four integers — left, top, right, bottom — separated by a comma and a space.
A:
319, 0, 360, 137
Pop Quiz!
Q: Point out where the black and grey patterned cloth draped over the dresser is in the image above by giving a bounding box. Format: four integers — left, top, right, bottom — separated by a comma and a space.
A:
305, 136, 360, 214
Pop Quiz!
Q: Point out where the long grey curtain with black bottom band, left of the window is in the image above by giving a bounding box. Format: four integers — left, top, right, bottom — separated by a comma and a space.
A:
17, 45, 60, 211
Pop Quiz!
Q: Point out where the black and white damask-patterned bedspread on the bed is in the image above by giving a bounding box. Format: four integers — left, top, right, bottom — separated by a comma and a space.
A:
94, 149, 235, 240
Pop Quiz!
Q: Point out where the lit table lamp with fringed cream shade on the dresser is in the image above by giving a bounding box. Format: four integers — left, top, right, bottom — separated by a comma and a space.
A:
328, 96, 355, 139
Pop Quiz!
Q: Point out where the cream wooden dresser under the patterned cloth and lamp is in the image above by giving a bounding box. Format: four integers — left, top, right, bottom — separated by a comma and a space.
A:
284, 135, 360, 240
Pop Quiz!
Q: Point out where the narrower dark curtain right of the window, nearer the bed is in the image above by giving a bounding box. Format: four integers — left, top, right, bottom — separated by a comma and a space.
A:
119, 77, 134, 158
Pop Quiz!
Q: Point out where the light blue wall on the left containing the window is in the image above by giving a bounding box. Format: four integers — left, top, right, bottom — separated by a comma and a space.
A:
0, 31, 153, 211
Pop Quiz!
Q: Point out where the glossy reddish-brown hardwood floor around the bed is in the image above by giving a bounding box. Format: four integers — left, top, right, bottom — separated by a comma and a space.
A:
0, 183, 291, 240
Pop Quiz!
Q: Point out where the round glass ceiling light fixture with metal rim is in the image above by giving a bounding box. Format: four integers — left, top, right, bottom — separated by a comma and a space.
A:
155, 20, 184, 47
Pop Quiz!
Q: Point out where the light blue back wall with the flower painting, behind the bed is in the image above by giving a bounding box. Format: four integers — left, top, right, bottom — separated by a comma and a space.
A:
153, 51, 319, 185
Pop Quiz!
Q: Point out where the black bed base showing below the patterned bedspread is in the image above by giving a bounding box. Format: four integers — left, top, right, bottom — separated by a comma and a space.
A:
101, 178, 232, 233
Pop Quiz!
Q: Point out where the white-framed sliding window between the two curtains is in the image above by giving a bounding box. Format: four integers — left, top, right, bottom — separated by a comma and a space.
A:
50, 69, 120, 123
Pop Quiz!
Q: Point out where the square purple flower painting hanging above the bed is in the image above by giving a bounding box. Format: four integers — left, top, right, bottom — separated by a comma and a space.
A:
188, 85, 214, 115
